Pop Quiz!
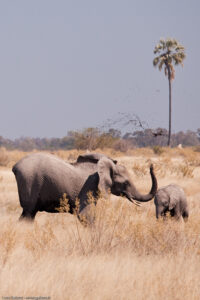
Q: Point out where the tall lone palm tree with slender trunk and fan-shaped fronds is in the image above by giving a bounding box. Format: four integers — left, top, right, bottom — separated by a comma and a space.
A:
153, 38, 185, 146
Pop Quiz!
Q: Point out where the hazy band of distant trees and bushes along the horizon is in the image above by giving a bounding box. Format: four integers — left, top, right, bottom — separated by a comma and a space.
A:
0, 128, 200, 152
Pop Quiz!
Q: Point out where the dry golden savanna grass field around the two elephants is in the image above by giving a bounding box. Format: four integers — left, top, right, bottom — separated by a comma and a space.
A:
0, 148, 200, 300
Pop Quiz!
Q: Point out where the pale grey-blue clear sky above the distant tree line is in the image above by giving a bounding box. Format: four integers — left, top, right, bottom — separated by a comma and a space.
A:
0, 0, 200, 139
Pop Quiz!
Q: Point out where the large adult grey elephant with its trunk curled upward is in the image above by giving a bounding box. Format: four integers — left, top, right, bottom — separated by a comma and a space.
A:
13, 153, 157, 220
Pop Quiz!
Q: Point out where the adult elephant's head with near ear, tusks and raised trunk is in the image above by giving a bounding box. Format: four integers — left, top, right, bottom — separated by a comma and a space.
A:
98, 157, 157, 202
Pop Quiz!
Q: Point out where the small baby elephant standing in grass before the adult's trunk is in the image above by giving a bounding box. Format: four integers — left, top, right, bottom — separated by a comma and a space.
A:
154, 184, 189, 221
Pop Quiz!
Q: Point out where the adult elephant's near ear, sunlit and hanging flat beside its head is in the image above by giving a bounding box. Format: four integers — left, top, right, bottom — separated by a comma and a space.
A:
97, 157, 116, 193
